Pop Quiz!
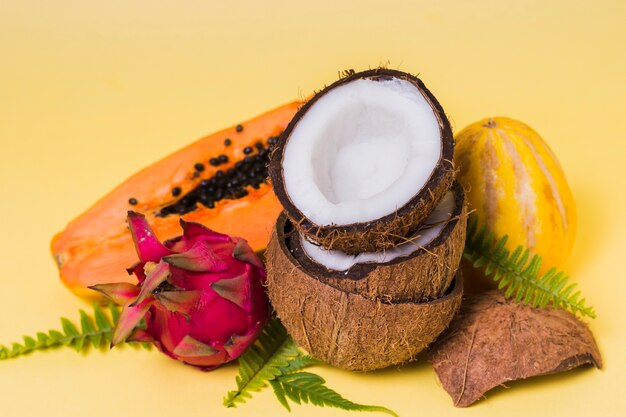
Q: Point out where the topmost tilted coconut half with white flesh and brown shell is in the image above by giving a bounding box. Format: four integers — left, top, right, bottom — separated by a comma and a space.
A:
269, 69, 454, 254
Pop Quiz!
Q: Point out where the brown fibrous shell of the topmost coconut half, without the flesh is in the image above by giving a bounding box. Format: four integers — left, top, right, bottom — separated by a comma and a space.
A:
269, 68, 454, 254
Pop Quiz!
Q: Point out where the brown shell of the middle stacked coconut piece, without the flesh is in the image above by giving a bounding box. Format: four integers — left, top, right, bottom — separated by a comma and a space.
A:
286, 183, 467, 302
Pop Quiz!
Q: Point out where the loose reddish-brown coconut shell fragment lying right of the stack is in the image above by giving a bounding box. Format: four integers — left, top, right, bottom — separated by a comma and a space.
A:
429, 290, 602, 407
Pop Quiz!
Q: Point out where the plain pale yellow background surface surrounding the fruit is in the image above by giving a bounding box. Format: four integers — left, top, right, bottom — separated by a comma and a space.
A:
0, 0, 626, 417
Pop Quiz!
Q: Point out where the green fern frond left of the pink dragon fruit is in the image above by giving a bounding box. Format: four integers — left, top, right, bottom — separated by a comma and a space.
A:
0, 304, 150, 360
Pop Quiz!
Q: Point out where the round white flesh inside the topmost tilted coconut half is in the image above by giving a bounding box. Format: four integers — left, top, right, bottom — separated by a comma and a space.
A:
283, 78, 441, 226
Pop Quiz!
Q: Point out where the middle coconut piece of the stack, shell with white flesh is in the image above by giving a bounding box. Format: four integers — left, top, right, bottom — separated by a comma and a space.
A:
286, 183, 467, 302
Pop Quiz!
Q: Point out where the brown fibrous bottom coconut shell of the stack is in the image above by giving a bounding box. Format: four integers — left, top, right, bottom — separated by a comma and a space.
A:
266, 218, 463, 371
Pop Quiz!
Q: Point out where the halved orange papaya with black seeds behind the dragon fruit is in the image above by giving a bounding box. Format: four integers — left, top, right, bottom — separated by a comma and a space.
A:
51, 102, 300, 301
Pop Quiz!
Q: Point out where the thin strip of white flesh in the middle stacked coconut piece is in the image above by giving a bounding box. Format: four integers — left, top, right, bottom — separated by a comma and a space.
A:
300, 191, 455, 271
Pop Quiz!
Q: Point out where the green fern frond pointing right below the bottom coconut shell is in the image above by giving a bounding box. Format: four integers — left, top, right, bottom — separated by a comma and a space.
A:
272, 372, 398, 417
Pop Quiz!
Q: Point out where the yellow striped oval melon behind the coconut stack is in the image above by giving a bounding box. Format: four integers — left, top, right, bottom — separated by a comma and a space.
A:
455, 117, 576, 271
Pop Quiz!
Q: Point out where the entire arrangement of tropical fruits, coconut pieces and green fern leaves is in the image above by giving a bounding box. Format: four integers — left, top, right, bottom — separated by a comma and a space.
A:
0, 68, 602, 417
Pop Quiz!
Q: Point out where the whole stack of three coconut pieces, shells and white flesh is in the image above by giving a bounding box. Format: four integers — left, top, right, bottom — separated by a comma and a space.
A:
266, 69, 466, 370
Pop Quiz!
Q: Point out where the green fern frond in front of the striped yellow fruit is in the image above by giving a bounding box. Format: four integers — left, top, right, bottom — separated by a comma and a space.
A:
463, 217, 596, 318
